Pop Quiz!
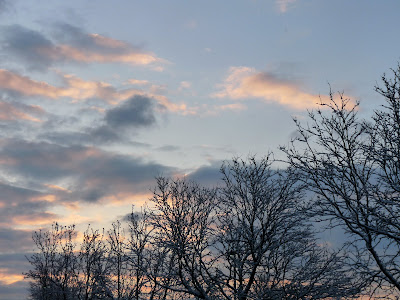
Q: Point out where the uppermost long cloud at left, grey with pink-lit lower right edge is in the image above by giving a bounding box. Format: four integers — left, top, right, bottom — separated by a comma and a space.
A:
1, 24, 166, 71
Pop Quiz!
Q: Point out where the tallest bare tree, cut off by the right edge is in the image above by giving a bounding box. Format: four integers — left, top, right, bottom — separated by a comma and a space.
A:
282, 72, 400, 295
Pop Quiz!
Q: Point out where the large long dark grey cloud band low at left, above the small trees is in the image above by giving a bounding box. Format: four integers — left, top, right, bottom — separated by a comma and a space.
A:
0, 140, 176, 203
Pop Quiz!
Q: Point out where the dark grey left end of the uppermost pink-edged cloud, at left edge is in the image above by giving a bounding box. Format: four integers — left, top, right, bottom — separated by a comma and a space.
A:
0, 25, 54, 71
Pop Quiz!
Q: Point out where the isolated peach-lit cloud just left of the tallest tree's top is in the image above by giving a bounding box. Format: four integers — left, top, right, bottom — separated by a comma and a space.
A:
213, 67, 329, 109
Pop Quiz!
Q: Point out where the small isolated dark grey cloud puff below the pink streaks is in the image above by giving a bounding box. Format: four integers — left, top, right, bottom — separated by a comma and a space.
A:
105, 96, 156, 128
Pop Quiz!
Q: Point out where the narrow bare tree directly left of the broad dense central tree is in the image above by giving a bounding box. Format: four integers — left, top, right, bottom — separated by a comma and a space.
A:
152, 177, 219, 299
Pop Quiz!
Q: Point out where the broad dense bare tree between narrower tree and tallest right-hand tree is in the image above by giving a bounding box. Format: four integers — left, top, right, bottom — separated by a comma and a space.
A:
214, 157, 360, 300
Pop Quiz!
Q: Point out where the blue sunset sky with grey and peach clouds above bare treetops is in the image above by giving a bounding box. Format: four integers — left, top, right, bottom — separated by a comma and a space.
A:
0, 0, 400, 300
